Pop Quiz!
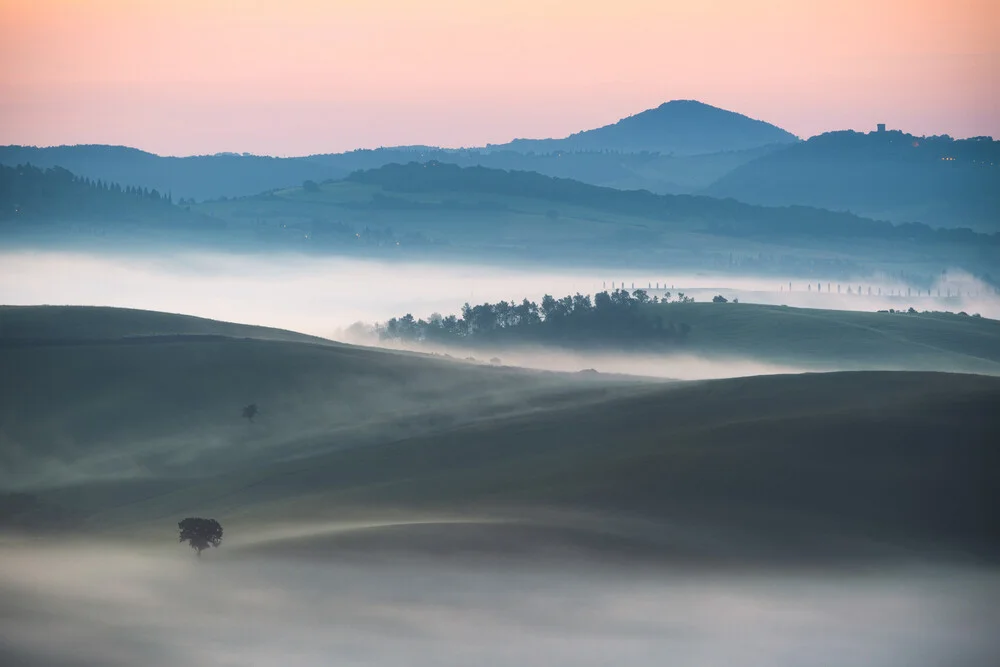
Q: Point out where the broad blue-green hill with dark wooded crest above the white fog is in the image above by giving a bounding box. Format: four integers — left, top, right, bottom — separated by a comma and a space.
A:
193, 162, 1000, 279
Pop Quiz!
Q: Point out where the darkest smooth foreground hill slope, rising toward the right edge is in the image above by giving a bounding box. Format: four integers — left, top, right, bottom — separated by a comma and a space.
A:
229, 373, 1000, 559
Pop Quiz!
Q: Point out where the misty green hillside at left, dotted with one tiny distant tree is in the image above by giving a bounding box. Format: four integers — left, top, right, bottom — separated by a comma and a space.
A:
0, 307, 648, 487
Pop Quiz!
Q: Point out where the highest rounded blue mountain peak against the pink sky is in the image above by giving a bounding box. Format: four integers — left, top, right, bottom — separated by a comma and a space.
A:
503, 100, 798, 155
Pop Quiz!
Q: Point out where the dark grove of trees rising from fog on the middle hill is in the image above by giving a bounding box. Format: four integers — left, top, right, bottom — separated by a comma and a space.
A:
377, 289, 693, 345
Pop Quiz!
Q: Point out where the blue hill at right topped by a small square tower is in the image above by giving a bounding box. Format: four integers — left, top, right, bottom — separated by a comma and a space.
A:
704, 131, 1000, 231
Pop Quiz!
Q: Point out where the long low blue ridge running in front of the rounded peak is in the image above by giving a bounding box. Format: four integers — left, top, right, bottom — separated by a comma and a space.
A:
0, 146, 778, 201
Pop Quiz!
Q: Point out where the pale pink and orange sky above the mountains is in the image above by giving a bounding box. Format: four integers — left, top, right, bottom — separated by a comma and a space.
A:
0, 0, 1000, 155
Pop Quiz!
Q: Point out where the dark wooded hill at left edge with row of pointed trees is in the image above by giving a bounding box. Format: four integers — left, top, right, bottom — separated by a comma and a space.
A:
0, 165, 181, 220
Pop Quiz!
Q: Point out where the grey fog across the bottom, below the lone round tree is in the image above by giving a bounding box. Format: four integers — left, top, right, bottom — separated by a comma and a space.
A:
0, 540, 1000, 667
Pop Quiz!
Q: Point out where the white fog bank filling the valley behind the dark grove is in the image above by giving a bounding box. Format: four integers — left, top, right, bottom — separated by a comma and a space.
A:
0, 251, 1000, 337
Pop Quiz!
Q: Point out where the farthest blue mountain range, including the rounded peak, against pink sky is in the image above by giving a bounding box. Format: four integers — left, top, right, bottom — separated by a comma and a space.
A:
0, 102, 796, 201
